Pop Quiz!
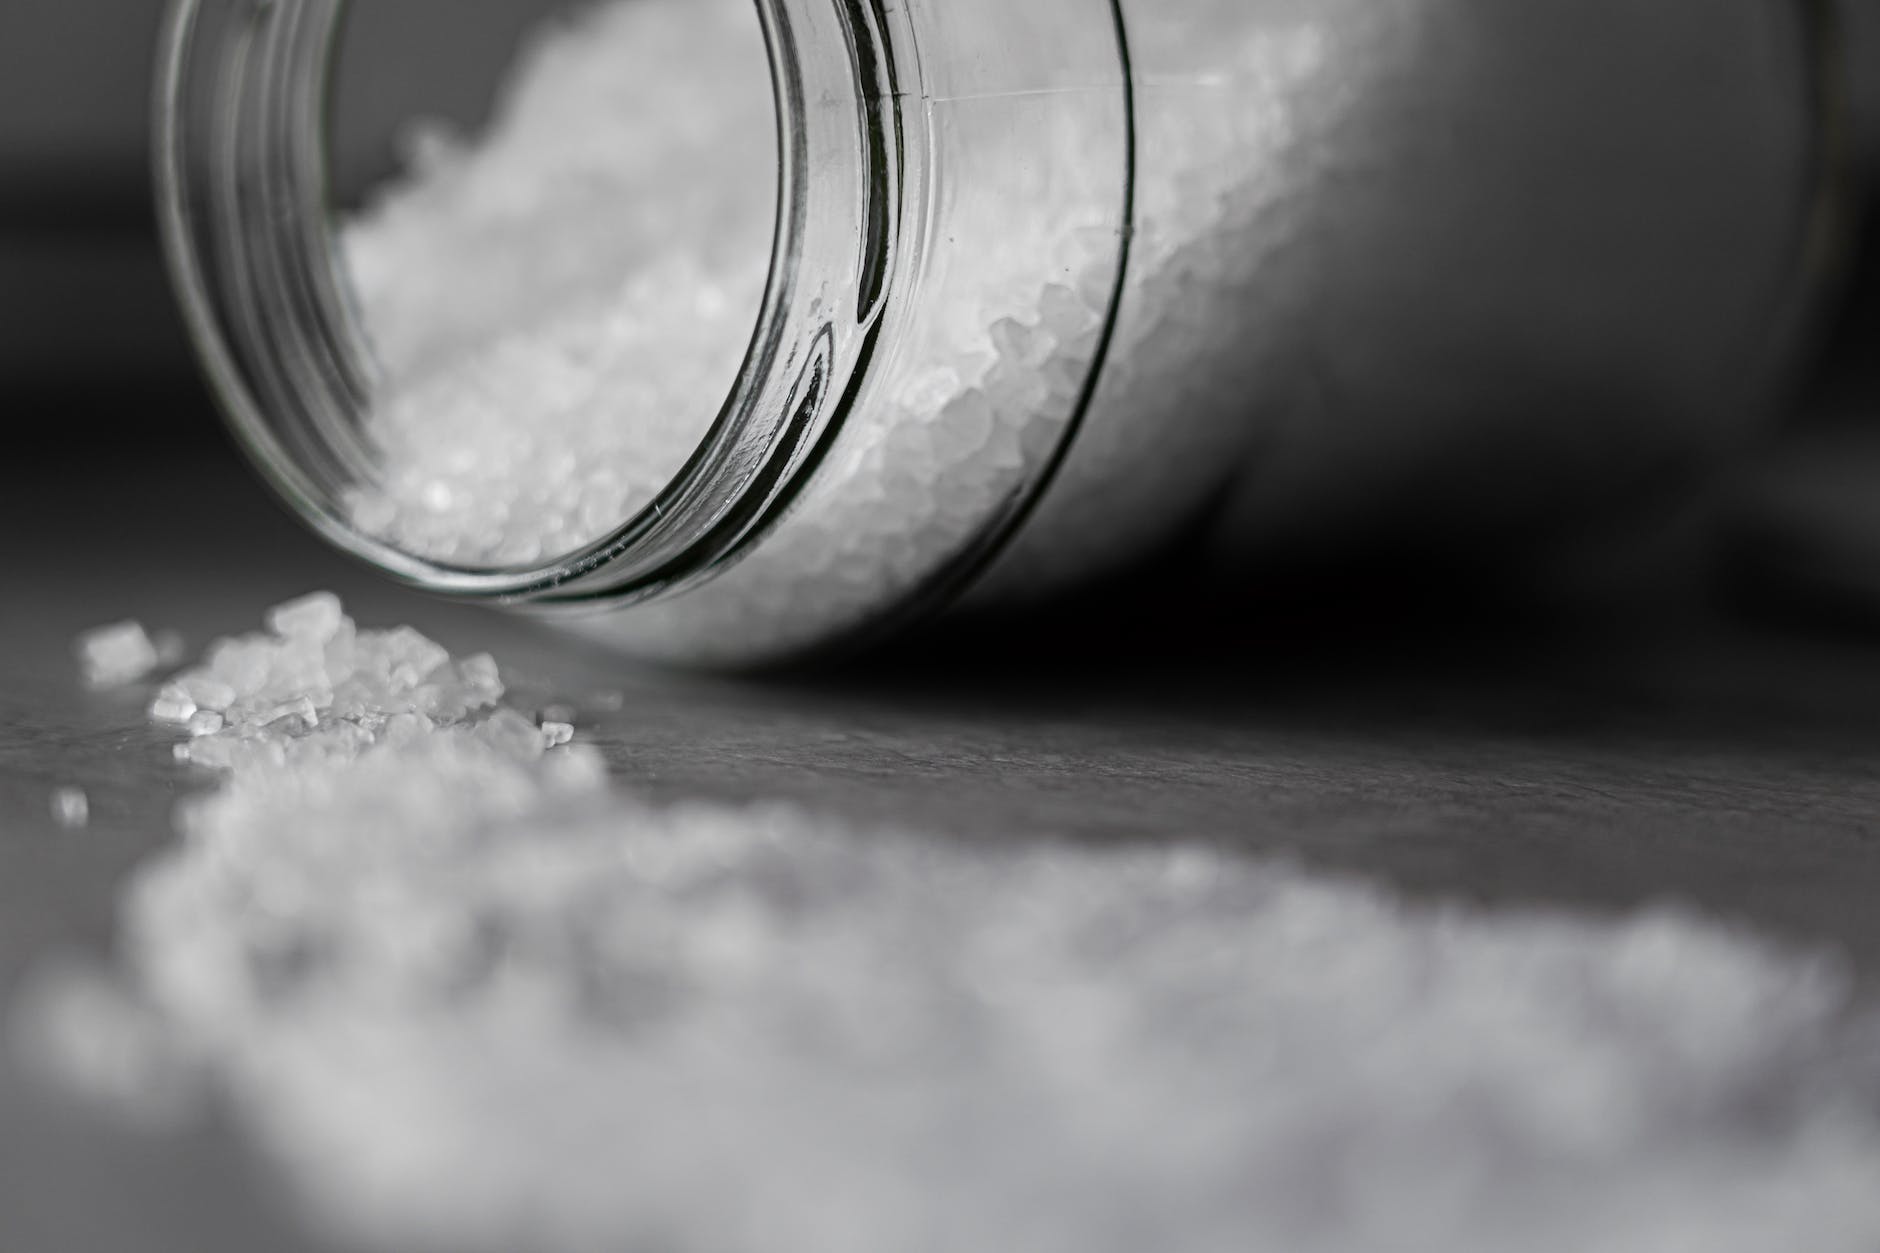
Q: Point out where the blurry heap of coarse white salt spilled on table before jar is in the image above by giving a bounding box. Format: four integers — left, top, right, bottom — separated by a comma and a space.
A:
15, 590, 1880, 1253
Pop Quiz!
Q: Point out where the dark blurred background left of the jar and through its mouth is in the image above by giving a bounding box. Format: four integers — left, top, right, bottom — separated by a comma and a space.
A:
0, 0, 562, 427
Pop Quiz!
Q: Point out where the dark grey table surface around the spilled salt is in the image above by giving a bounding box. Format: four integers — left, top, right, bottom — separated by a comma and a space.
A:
0, 449, 1880, 1253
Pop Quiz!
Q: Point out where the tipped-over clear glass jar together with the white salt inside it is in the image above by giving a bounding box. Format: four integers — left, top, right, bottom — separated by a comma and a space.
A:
158, 0, 1852, 666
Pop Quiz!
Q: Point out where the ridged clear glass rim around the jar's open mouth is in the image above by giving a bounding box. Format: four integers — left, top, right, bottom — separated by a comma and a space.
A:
156, 0, 899, 602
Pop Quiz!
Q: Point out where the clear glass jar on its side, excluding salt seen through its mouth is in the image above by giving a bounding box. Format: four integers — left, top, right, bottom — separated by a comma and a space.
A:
158, 0, 1846, 664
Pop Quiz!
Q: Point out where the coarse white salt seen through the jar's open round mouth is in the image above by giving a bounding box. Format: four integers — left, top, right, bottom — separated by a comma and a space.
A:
344, 0, 776, 566
